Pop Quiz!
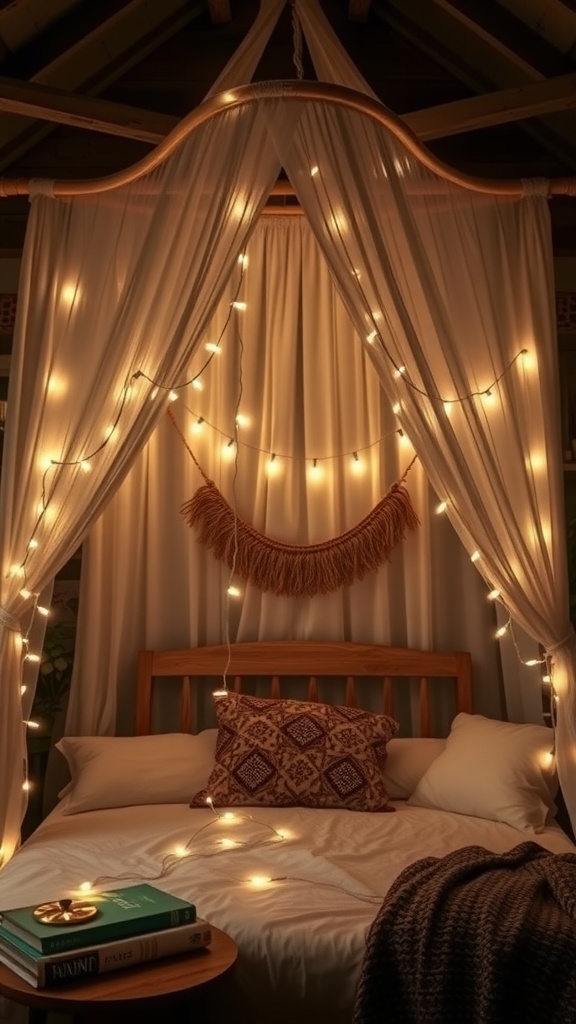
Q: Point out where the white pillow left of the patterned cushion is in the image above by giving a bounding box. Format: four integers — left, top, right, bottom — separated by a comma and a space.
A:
55, 729, 217, 814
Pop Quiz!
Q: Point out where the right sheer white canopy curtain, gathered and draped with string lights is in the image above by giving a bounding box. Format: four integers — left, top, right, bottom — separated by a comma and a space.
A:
272, 103, 576, 822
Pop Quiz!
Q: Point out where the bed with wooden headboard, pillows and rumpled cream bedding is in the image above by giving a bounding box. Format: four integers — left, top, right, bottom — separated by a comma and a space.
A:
0, 641, 576, 1024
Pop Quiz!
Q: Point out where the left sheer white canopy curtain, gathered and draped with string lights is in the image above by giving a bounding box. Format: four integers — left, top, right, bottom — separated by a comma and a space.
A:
0, 105, 278, 858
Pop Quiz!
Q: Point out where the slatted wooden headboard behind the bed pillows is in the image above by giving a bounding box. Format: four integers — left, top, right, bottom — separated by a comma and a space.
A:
135, 640, 472, 736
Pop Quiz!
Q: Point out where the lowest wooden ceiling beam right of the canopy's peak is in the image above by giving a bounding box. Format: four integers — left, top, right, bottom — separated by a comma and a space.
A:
403, 73, 576, 142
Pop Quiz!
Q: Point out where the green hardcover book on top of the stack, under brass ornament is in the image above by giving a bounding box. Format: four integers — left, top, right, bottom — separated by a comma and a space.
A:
0, 884, 196, 954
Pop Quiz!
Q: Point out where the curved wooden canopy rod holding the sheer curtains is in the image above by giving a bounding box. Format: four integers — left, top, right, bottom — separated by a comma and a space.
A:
0, 79, 576, 197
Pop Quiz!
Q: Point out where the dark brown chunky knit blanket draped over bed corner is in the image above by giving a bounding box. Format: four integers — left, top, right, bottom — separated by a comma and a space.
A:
354, 842, 576, 1024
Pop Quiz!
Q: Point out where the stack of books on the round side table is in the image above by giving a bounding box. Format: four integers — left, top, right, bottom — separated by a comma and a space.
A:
0, 884, 212, 988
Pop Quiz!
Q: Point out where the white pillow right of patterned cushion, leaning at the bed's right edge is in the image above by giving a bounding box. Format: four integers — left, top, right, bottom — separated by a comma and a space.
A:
408, 713, 557, 833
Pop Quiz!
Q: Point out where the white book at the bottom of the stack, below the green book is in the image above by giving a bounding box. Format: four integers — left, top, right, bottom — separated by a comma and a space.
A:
0, 918, 212, 988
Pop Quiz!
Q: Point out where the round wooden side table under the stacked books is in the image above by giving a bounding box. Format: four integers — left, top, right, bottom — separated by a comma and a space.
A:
0, 926, 238, 1024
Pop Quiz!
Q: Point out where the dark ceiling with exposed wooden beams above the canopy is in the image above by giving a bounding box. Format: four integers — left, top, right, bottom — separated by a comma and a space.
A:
0, 0, 576, 255
